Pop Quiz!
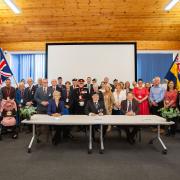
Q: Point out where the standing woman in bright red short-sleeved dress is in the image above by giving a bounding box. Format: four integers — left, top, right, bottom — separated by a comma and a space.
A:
133, 79, 149, 115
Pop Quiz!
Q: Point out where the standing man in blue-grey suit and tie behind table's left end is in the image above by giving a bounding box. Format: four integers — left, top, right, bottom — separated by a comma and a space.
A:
34, 79, 53, 114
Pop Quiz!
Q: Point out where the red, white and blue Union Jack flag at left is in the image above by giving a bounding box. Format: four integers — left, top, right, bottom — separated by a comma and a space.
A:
0, 48, 13, 84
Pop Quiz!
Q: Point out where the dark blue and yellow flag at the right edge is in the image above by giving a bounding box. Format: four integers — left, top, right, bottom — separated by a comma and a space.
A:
165, 54, 180, 91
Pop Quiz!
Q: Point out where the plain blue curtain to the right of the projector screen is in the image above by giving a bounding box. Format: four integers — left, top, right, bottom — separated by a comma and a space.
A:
137, 53, 173, 82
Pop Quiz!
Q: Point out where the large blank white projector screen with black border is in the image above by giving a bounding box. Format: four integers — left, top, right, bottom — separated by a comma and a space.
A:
46, 43, 136, 83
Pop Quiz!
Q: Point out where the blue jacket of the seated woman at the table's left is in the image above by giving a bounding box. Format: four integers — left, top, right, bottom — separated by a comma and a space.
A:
47, 99, 64, 115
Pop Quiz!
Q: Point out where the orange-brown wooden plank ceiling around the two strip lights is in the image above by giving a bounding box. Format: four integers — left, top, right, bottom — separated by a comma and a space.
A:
0, 0, 180, 43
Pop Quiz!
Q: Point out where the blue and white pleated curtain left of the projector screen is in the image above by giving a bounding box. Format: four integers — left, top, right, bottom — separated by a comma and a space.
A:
10, 53, 45, 82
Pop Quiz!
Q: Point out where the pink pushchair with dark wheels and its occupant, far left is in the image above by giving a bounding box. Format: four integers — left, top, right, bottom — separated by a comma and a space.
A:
0, 99, 18, 139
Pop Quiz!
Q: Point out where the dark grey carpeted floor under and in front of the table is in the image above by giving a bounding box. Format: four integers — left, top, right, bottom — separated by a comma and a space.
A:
0, 129, 180, 180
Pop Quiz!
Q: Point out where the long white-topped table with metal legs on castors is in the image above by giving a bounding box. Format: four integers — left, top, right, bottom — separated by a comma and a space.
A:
22, 114, 174, 154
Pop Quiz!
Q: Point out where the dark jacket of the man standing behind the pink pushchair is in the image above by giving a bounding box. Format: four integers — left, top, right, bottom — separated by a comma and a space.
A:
0, 86, 16, 100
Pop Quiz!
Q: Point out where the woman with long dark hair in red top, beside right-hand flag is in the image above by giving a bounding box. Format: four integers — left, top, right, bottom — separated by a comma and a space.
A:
164, 81, 178, 135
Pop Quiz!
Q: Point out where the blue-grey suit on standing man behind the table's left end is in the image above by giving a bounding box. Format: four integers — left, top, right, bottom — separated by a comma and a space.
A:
34, 87, 53, 113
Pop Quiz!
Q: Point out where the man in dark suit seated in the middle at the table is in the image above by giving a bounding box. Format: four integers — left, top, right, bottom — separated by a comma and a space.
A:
85, 92, 107, 141
